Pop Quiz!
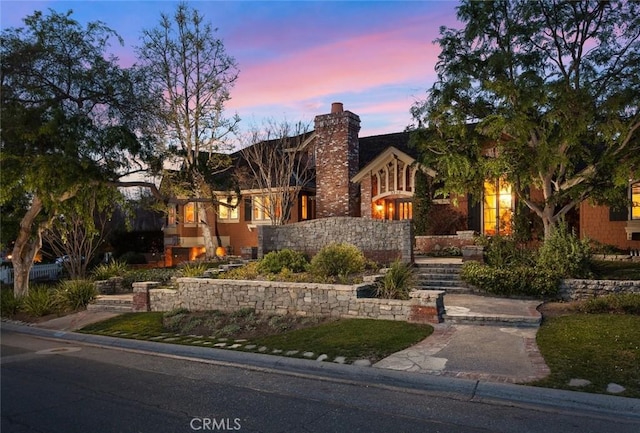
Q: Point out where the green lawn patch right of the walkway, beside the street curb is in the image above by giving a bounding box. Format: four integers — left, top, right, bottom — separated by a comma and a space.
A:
534, 314, 640, 398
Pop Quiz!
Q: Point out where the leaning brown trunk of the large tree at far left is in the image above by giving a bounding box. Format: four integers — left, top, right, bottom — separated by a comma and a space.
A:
12, 196, 44, 297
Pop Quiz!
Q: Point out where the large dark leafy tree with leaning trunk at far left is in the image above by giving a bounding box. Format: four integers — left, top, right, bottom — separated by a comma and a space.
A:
0, 11, 161, 295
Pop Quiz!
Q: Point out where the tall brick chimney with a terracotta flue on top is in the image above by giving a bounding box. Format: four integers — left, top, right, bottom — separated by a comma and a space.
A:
315, 102, 360, 218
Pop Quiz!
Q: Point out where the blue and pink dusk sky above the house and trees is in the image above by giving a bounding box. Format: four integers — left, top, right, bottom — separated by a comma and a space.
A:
0, 0, 460, 136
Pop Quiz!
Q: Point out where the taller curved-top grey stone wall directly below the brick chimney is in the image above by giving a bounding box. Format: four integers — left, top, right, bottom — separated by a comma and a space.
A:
258, 217, 413, 263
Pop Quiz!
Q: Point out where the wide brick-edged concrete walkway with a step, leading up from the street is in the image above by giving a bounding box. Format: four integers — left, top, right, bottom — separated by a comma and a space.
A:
374, 295, 549, 383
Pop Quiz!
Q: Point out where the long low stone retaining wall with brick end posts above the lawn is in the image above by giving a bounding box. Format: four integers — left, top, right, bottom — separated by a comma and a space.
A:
133, 278, 444, 323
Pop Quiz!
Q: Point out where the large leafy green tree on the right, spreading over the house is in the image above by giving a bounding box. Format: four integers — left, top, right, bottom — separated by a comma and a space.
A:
412, 0, 640, 235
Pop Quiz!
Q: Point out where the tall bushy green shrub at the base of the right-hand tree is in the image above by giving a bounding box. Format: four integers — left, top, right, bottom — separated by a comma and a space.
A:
538, 221, 591, 278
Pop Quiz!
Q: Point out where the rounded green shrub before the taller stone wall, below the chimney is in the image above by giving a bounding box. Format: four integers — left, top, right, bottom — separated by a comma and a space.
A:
310, 243, 366, 278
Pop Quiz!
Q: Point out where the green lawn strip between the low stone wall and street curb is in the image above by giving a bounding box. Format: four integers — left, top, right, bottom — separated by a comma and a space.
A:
80, 312, 433, 362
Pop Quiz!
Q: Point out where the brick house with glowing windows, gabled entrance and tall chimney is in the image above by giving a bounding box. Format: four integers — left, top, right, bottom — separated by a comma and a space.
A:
164, 103, 640, 265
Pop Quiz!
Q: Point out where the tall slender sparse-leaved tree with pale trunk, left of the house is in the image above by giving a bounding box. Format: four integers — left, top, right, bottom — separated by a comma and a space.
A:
138, 3, 239, 255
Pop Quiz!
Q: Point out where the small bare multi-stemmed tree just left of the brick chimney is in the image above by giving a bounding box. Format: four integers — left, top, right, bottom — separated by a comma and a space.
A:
239, 120, 315, 225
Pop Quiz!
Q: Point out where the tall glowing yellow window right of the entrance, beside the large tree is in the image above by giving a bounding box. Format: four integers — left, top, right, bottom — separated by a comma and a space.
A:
483, 179, 513, 235
